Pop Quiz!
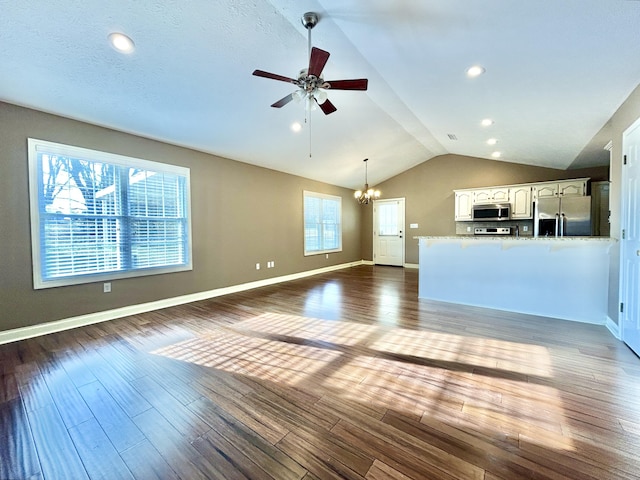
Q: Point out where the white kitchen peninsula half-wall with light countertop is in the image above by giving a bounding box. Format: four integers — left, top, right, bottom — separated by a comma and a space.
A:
416, 236, 613, 324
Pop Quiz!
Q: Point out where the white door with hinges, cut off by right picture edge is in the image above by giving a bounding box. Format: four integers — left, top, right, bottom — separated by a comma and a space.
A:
620, 119, 640, 355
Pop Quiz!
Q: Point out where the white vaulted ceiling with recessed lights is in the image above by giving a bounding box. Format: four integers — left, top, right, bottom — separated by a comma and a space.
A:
0, 0, 640, 188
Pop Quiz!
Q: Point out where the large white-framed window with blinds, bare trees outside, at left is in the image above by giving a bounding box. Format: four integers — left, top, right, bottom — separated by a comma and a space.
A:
29, 138, 192, 289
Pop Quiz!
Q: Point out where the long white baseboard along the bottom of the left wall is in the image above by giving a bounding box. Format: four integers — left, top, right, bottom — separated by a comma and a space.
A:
0, 260, 366, 345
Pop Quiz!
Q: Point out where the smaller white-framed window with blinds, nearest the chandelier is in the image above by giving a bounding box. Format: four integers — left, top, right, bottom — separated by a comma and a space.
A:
304, 191, 342, 255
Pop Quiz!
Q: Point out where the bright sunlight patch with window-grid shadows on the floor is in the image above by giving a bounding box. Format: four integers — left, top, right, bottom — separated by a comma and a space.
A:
152, 313, 573, 450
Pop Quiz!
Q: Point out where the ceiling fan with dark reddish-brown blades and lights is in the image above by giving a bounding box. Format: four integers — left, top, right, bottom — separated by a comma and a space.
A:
253, 12, 369, 115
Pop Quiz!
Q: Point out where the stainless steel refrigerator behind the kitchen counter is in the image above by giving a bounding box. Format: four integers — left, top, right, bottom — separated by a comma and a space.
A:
533, 196, 591, 237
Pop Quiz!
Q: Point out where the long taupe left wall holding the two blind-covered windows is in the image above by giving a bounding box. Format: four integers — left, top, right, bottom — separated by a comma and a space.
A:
0, 102, 362, 331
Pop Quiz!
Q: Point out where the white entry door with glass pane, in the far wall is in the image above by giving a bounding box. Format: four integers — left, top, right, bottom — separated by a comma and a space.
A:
373, 198, 404, 267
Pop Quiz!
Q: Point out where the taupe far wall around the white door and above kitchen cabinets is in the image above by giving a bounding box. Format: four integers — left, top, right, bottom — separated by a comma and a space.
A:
362, 155, 608, 264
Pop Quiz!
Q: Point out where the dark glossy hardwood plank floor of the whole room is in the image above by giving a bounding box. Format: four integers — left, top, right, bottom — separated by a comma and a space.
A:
0, 266, 640, 480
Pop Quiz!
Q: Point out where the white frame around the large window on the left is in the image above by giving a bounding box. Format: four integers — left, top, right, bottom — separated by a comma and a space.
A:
27, 138, 193, 290
